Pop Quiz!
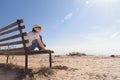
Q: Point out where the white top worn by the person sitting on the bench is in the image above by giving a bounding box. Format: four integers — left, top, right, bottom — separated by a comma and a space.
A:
24, 31, 40, 47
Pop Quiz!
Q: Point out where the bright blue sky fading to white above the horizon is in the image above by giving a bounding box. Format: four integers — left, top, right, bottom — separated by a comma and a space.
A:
0, 0, 120, 55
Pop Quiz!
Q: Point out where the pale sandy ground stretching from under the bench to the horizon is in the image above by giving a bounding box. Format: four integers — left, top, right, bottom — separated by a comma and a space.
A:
0, 55, 120, 80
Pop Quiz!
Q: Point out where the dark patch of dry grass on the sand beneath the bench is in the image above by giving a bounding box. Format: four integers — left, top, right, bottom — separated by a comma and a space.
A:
0, 64, 54, 80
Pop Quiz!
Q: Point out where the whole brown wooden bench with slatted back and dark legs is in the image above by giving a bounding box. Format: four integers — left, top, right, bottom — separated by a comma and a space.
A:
0, 19, 54, 73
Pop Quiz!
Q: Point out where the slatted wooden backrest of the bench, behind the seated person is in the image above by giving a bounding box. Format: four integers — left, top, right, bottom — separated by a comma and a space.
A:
0, 19, 28, 55
